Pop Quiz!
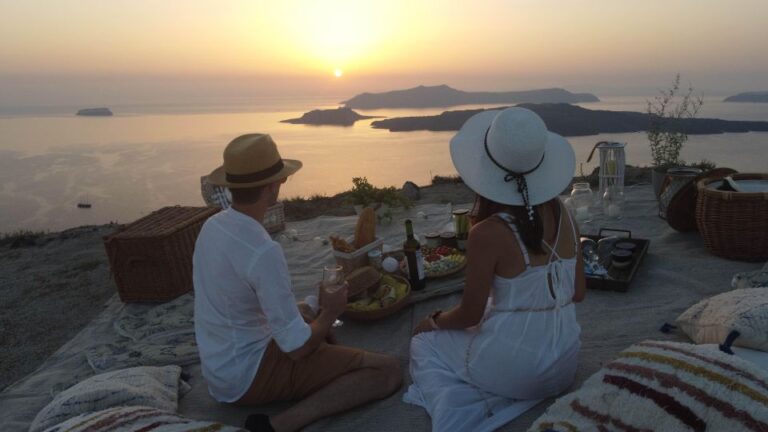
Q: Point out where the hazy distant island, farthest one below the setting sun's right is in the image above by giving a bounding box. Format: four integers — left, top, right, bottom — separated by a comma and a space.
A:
342, 85, 600, 109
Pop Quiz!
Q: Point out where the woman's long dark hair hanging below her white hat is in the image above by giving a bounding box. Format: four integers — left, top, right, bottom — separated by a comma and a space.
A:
472, 195, 557, 254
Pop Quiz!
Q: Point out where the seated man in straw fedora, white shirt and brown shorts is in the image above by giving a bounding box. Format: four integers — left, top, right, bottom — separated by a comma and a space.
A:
194, 134, 402, 431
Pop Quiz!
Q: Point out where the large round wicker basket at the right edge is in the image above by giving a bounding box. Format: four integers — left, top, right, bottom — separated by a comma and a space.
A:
696, 174, 768, 261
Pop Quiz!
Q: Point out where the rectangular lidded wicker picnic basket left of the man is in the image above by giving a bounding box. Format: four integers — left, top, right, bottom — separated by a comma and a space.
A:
104, 206, 220, 303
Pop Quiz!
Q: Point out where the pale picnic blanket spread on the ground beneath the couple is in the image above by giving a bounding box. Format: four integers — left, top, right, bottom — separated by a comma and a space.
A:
0, 186, 762, 432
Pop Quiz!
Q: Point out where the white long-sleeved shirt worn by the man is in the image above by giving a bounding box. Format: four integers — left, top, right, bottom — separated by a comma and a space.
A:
193, 207, 312, 402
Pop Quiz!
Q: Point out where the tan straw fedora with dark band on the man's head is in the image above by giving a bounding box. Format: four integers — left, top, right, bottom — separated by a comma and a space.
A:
208, 134, 302, 189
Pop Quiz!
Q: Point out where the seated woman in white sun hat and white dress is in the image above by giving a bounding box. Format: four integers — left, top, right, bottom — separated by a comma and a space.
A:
404, 108, 585, 431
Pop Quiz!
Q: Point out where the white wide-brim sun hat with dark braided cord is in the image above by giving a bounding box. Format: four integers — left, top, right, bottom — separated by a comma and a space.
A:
450, 107, 576, 206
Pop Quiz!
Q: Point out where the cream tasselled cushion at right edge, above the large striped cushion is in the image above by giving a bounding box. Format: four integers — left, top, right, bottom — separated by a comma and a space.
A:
677, 288, 768, 351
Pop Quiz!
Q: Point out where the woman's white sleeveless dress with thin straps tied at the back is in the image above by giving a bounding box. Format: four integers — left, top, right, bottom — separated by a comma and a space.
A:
403, 211, 581, 431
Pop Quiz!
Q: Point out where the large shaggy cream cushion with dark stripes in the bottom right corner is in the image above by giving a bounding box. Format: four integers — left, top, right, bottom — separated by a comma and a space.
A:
529, 341, 768, 432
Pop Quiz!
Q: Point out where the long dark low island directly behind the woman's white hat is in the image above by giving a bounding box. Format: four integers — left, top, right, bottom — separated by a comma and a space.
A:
371, 104, 768, 136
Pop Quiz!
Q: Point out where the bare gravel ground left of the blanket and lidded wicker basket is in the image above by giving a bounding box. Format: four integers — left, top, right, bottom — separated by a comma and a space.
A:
0, 225, 115, 390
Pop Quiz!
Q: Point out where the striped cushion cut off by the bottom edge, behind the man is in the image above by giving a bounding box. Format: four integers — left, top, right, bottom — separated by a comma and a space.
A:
40, 406, 245, 432
